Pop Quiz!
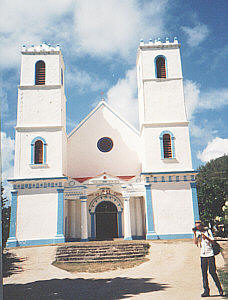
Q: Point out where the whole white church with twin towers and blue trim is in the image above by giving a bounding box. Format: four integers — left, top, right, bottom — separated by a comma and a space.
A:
7, 38, 199, 247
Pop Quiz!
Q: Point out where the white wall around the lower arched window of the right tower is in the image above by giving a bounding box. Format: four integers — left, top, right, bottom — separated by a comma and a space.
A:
142, 126, 192, 172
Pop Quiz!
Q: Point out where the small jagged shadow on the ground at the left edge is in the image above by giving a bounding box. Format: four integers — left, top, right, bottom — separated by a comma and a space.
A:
2, 252, 25, 277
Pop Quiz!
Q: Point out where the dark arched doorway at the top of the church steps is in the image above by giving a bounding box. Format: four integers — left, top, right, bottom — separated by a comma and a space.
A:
95, 201, 118, 240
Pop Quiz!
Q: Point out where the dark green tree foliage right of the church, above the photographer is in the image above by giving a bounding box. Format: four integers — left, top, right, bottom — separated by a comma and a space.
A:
196, 155, 228, 224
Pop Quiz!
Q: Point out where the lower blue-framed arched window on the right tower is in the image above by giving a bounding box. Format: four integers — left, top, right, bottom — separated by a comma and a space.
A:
159, 131, 175, 159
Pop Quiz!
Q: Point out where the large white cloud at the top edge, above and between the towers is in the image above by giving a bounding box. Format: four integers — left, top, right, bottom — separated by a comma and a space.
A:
75, 0, 167, 58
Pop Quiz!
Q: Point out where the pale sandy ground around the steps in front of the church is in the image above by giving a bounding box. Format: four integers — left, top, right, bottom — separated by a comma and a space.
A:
4, 240, 226, 300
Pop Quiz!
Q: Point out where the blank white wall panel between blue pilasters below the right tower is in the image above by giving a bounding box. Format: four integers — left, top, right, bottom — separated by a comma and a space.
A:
152, 182, 194, 235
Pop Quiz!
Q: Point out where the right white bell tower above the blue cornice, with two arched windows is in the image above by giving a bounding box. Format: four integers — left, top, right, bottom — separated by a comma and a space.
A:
137, 38, 192, 172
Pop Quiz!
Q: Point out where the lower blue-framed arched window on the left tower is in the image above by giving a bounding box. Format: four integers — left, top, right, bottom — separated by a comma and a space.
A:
31, 136, 47, 165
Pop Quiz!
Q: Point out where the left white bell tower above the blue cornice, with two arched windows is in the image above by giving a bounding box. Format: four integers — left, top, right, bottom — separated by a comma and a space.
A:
14, 43, 67, 178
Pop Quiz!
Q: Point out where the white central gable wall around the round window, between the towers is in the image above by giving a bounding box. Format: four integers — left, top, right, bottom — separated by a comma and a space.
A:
67, 102, 141, 178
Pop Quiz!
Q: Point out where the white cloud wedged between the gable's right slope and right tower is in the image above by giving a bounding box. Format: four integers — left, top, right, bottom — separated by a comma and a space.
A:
107, 68, 138, 127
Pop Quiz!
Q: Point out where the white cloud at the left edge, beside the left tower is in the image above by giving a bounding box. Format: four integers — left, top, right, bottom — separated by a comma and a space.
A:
1, 132, 14, 200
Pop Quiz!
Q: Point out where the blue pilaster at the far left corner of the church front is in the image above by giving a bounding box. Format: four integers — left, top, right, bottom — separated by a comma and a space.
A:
6, 191, 18, 248
